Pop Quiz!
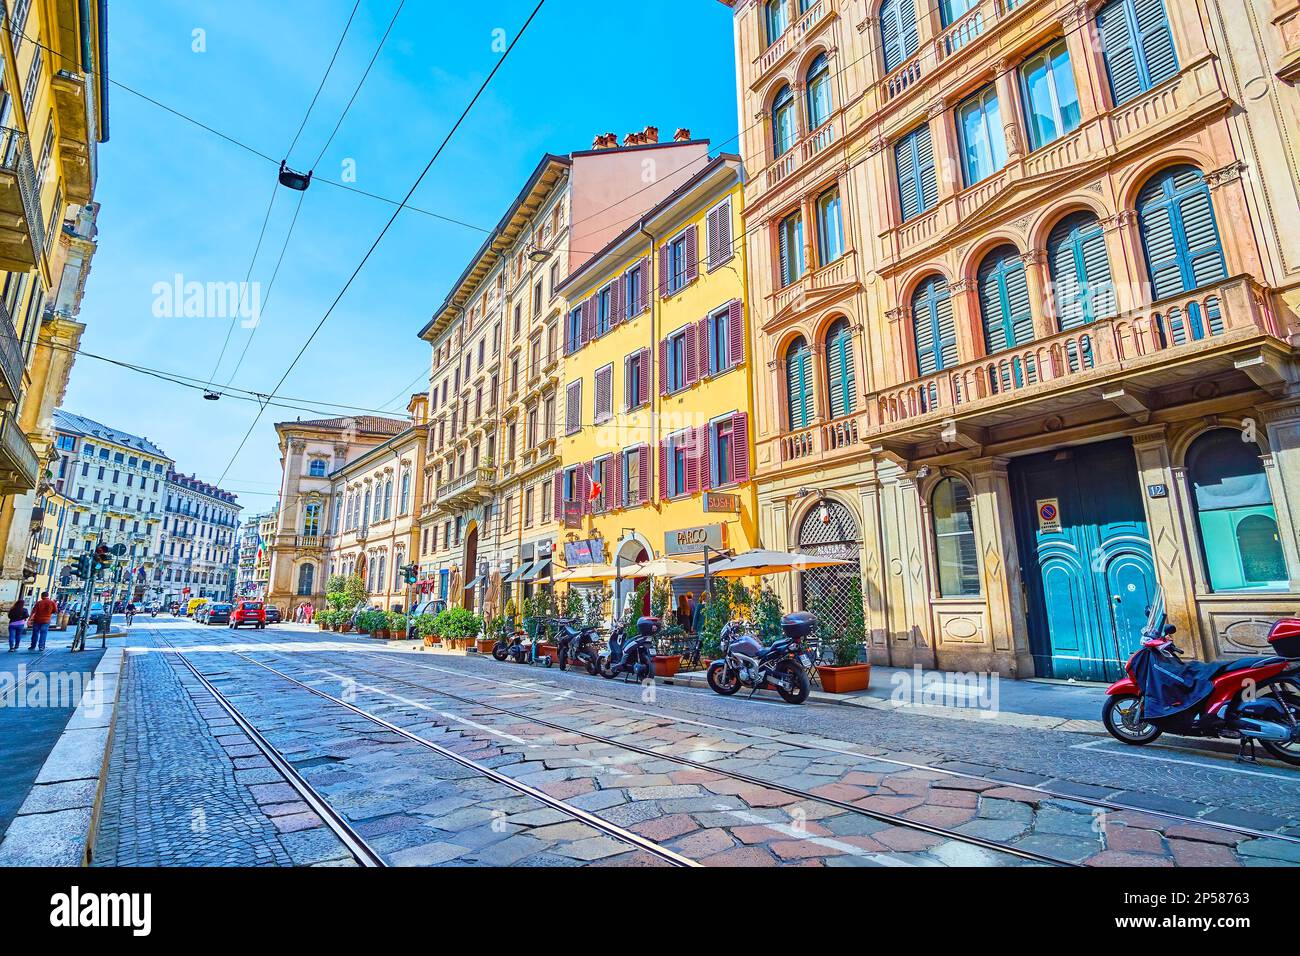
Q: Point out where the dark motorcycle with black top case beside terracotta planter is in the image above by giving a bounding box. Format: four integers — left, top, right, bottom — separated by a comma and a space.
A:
705, 611, 818, 704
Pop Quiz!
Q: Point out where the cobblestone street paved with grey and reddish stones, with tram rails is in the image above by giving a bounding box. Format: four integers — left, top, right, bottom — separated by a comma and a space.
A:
78, 620, 1300, 866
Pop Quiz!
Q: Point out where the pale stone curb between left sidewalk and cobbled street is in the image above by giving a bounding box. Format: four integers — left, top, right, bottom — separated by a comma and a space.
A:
0, 648, 126, 866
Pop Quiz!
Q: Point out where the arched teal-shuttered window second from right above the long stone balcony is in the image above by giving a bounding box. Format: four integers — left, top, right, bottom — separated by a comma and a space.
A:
1048, 212, 1117, 332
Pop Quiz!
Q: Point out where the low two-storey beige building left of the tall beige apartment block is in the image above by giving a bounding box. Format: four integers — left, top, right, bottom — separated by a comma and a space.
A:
321, 392, 429, 610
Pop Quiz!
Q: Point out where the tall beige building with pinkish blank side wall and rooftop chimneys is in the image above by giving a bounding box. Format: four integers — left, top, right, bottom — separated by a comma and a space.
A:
419, 127, 709, 607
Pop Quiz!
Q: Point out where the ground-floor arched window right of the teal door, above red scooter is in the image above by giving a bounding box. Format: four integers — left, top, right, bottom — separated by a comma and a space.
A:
1187, 428, 1288, 591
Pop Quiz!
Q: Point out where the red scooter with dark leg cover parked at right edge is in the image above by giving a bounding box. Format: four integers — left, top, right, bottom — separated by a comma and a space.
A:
1101, 594, 1300, 765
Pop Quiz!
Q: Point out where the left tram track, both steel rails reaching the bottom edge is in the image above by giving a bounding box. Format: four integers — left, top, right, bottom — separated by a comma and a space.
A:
155, 632, 699, 868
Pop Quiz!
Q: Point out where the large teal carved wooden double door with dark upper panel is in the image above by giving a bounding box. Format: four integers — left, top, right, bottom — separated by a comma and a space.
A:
1011, 440, 1156, 680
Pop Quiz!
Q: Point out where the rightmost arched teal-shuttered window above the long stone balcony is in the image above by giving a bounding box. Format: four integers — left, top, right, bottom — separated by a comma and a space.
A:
1138, 165, 1227, 302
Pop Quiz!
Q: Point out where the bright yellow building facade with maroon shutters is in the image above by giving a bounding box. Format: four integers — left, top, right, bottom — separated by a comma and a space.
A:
551, 155, 757, 607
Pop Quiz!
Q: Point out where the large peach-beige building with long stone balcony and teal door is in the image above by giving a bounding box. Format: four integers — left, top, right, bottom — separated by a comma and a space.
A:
729, 0, 1300, 679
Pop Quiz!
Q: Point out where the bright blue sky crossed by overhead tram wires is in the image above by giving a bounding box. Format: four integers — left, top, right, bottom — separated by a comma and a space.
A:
64, 0, 737, 511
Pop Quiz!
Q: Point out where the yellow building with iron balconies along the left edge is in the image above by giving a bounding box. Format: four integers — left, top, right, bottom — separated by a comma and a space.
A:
0, 0, 108, 601
